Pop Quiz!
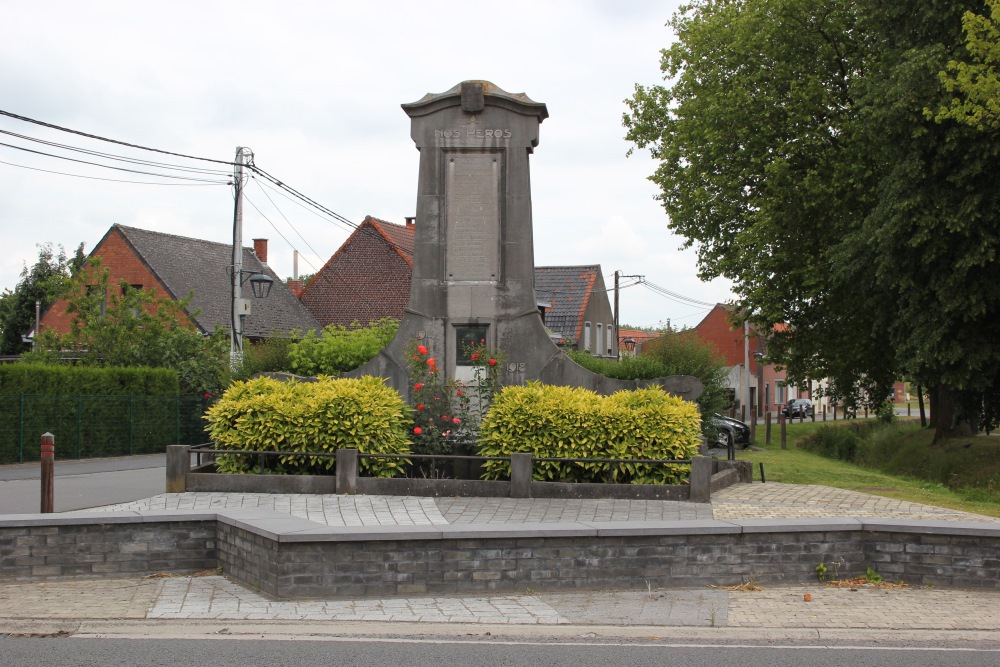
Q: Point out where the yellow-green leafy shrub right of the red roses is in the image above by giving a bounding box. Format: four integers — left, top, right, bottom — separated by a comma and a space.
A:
479, 382, 701, 484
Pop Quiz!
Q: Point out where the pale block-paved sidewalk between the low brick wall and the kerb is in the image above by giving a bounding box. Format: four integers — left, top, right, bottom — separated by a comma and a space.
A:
0, 576, 1000, 634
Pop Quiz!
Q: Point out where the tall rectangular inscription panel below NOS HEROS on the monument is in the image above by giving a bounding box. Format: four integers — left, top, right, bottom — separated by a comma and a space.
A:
445, 153, 502, 281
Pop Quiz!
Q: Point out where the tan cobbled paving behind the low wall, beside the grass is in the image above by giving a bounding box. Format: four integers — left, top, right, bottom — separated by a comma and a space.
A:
712, 482, 1000, 521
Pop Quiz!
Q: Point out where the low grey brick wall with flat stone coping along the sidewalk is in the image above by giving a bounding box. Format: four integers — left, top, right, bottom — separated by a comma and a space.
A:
0, 510, 1000, 598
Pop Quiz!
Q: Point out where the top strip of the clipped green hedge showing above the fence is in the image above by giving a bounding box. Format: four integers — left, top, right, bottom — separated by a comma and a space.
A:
0, 363, 180, 396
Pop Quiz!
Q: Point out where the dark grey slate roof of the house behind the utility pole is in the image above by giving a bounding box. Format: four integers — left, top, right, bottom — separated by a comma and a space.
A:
115, 225, 321, 338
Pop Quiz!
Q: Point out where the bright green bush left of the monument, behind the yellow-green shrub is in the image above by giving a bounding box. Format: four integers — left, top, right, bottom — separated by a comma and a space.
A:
288, 317, 399, 375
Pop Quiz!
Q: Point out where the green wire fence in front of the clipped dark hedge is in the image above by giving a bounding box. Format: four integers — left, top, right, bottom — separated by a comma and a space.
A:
0, 394, 208, 464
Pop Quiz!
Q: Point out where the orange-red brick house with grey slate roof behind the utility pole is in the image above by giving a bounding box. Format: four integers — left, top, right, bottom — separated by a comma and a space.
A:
41, 225, 319, 341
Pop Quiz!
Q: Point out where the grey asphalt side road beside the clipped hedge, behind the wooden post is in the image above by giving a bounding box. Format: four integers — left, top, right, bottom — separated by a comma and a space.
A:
0, 451, 166, 516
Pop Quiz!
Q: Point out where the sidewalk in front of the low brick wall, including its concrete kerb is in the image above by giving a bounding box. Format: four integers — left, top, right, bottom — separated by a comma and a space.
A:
0, 575, 1000, 641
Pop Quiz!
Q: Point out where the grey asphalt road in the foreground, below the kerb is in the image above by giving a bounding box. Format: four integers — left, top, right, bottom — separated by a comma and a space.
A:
0, 637, 1000, 667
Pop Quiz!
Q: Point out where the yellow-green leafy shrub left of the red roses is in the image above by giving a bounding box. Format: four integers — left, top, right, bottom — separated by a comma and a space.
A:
206, 377, 410, 477
